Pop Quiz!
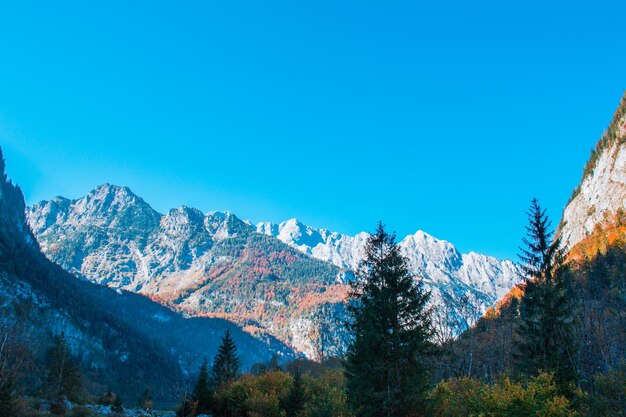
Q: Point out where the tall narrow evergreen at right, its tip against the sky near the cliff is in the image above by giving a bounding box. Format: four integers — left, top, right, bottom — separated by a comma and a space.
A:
517, 199, 576, 389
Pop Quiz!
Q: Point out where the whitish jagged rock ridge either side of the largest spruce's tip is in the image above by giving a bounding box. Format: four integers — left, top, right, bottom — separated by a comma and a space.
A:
257, 219, 520, 322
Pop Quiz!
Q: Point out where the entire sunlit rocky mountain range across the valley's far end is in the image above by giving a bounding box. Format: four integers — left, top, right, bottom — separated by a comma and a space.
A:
27, 184, 517, 357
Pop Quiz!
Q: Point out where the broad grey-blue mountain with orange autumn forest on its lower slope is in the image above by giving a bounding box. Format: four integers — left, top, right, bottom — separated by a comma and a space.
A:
27, 188, 347, 356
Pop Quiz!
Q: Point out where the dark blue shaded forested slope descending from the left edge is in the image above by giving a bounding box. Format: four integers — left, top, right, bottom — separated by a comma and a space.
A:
0, 151, 292, 406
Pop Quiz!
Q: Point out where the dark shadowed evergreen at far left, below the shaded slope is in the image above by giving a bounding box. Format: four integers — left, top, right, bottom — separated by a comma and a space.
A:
45, 334, 82, 401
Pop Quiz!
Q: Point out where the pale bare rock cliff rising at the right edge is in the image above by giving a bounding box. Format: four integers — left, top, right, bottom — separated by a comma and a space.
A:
560, 94, 626, 248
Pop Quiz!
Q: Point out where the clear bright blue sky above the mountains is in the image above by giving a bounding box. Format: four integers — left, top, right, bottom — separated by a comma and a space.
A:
0, 0, 626, 258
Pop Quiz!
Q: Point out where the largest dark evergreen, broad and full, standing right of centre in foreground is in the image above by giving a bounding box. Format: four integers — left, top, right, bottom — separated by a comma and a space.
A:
346, 223, 433, 417
